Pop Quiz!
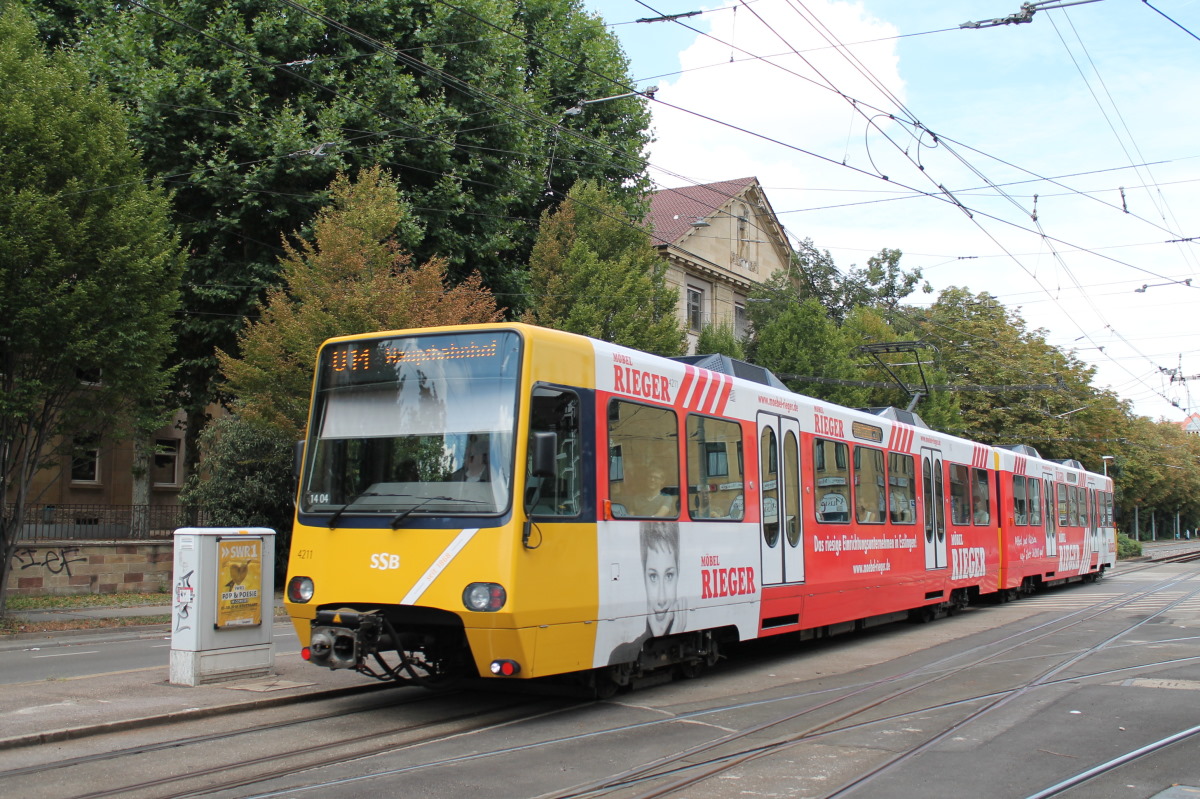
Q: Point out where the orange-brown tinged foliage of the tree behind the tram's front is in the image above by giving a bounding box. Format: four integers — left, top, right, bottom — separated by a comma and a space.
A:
220, 168, 502, 439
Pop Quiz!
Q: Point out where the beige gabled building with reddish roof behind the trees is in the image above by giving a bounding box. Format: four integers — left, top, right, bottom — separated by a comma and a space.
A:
647, 178, 792, 354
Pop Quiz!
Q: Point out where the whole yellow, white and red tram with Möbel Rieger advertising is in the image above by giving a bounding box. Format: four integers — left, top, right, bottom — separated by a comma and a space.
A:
286, 324, 1116, 685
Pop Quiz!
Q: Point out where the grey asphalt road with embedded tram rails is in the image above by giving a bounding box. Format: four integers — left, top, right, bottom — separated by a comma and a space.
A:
0, 551, 1200, 799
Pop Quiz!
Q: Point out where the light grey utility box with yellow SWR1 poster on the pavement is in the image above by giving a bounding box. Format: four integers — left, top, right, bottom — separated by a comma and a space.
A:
170, 527, 275, 686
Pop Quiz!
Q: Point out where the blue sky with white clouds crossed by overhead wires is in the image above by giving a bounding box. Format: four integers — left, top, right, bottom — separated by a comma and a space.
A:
584, 0, 1200, 421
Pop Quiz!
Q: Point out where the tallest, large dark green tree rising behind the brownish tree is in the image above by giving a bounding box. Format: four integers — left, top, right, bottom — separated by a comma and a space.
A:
23, 0, 649, 472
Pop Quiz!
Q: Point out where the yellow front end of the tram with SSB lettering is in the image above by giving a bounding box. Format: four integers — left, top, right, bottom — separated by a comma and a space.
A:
286, 325, 596, 680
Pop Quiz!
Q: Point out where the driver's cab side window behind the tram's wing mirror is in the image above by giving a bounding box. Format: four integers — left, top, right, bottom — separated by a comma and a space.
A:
526, 386, 583, 516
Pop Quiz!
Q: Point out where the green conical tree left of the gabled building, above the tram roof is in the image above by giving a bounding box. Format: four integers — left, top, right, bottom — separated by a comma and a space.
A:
524, 181, 685, 355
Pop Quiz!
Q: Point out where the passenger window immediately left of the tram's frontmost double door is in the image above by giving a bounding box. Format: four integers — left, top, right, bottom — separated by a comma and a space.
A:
688, 414, 745, 521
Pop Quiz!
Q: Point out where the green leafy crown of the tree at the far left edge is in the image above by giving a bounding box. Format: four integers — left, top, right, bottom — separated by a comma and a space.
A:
0, 5, 182, 611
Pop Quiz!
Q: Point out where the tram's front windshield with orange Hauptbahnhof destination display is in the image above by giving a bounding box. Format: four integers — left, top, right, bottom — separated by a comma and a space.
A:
300, 330, 521, 515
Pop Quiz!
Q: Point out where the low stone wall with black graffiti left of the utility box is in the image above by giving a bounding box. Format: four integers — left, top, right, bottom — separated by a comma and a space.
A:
7, 540, 175, 596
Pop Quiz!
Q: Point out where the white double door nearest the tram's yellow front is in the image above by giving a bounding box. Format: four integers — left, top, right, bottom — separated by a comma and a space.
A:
758, 414, 804, 585
